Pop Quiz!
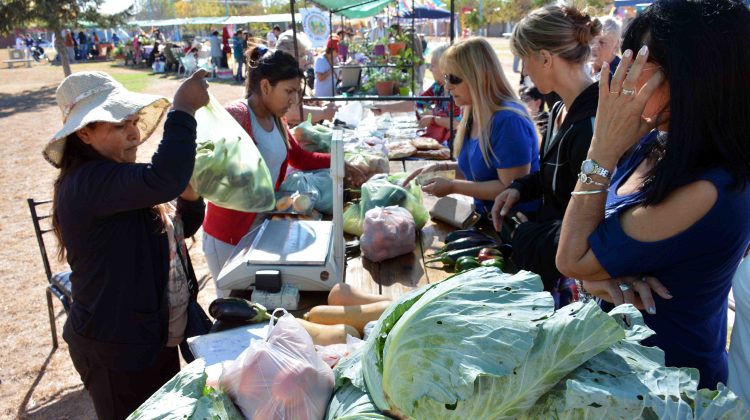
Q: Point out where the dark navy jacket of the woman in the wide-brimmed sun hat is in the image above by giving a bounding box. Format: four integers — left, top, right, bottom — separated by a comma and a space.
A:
57, 111, 204, 371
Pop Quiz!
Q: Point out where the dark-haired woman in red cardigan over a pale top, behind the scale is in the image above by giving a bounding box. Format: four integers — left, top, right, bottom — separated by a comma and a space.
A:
203, 45, 362, 296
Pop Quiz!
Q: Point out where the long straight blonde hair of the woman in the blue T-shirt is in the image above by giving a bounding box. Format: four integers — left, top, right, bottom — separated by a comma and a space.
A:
440, 38, 531, 166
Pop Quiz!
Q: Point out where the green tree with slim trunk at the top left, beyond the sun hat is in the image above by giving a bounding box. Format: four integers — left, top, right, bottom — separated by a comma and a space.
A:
0, 0, 132, 77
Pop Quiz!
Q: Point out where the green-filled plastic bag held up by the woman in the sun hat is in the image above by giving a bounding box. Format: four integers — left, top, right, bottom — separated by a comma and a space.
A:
190, 94, 274, 212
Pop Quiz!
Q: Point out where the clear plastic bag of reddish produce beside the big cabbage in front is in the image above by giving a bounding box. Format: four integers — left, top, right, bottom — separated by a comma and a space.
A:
220, 314, 334, 420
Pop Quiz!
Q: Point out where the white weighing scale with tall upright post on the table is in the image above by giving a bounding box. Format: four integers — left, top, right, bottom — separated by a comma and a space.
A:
216, 130, 344, 291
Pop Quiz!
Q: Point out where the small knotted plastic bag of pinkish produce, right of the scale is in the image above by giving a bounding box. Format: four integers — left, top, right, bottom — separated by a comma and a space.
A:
359, 206, 417, 262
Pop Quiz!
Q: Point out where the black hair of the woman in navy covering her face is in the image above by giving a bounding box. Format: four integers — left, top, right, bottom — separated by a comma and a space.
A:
622, 0, 750, 205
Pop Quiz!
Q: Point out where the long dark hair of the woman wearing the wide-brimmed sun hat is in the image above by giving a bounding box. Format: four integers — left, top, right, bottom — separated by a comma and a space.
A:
52, 128, 168, 261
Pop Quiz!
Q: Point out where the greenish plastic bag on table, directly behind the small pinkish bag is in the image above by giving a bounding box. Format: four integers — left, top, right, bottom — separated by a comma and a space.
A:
344, 172, 430, 236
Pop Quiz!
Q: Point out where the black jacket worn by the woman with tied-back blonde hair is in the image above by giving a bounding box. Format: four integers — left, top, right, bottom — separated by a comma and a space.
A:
510, 83, 599, 290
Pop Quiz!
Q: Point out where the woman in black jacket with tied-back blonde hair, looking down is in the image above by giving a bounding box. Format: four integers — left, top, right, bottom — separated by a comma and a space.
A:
492, 5, 601, 291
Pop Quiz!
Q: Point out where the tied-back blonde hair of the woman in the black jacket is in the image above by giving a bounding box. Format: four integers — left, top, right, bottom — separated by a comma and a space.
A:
510, 5, 602, 63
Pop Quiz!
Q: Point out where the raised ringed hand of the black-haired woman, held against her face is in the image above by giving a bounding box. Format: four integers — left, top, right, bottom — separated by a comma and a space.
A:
589, 45, 664, 163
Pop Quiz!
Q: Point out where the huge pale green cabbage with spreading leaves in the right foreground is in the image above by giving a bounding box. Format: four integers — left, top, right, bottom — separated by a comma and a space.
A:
328, 267, 747, 419
